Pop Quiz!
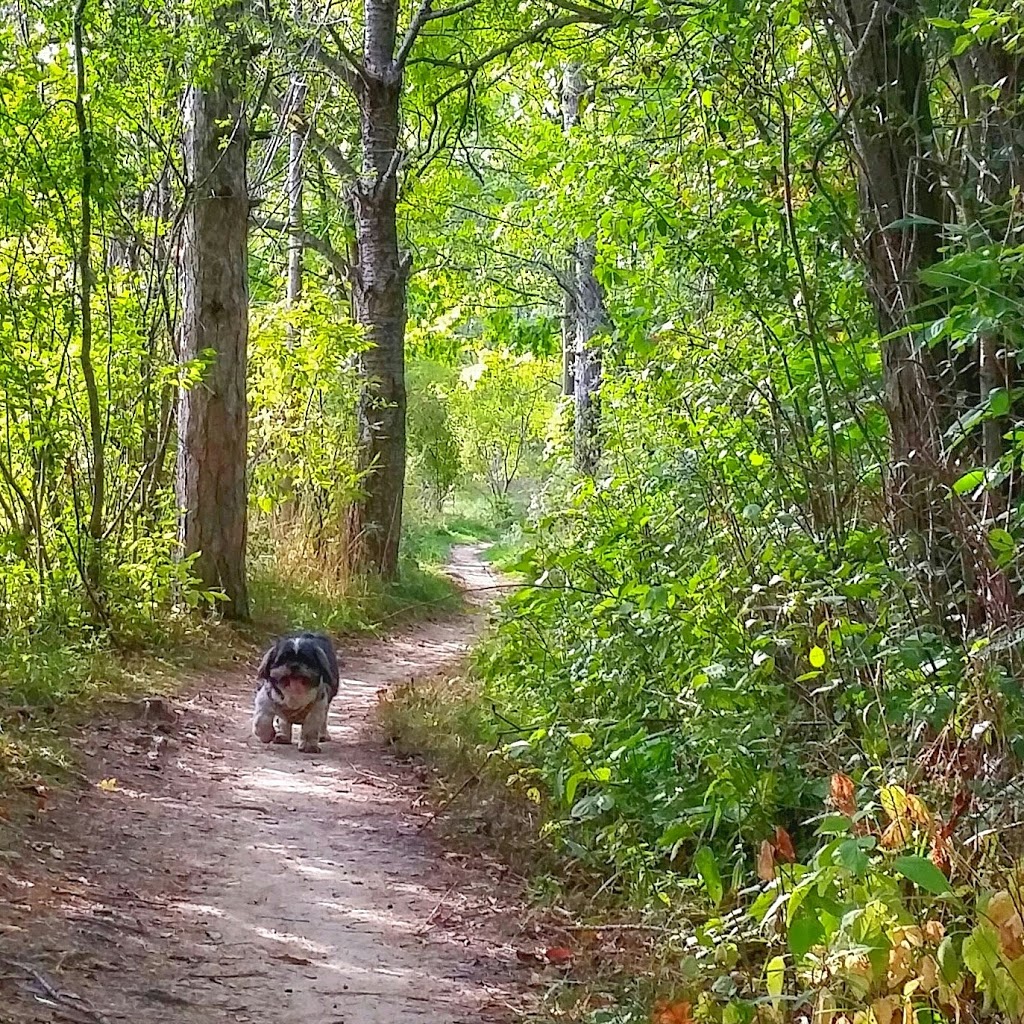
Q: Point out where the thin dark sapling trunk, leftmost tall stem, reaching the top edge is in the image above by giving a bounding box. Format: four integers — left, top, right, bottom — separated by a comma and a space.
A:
73, 0, 106, 603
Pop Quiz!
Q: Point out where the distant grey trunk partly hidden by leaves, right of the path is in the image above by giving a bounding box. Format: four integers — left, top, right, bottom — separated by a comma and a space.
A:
562, 65, 607, 474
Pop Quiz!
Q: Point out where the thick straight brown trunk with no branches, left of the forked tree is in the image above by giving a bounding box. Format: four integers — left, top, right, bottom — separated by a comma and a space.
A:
178, 8, 249, 618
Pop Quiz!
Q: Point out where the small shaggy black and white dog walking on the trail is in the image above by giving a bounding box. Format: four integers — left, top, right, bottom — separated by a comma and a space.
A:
253, 633, 338, 754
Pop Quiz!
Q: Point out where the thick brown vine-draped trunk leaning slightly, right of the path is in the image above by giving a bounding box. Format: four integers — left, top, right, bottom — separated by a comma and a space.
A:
839, 0, 949, 539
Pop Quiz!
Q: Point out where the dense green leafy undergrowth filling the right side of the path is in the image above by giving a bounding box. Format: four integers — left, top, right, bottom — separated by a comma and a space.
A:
381, 382, 1024, 1024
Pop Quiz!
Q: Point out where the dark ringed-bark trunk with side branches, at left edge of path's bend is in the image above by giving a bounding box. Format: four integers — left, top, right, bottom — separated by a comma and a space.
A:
349, 0, 411, 580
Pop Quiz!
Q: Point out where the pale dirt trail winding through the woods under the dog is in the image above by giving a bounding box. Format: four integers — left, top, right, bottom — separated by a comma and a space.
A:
0, 546, 515, 1024
